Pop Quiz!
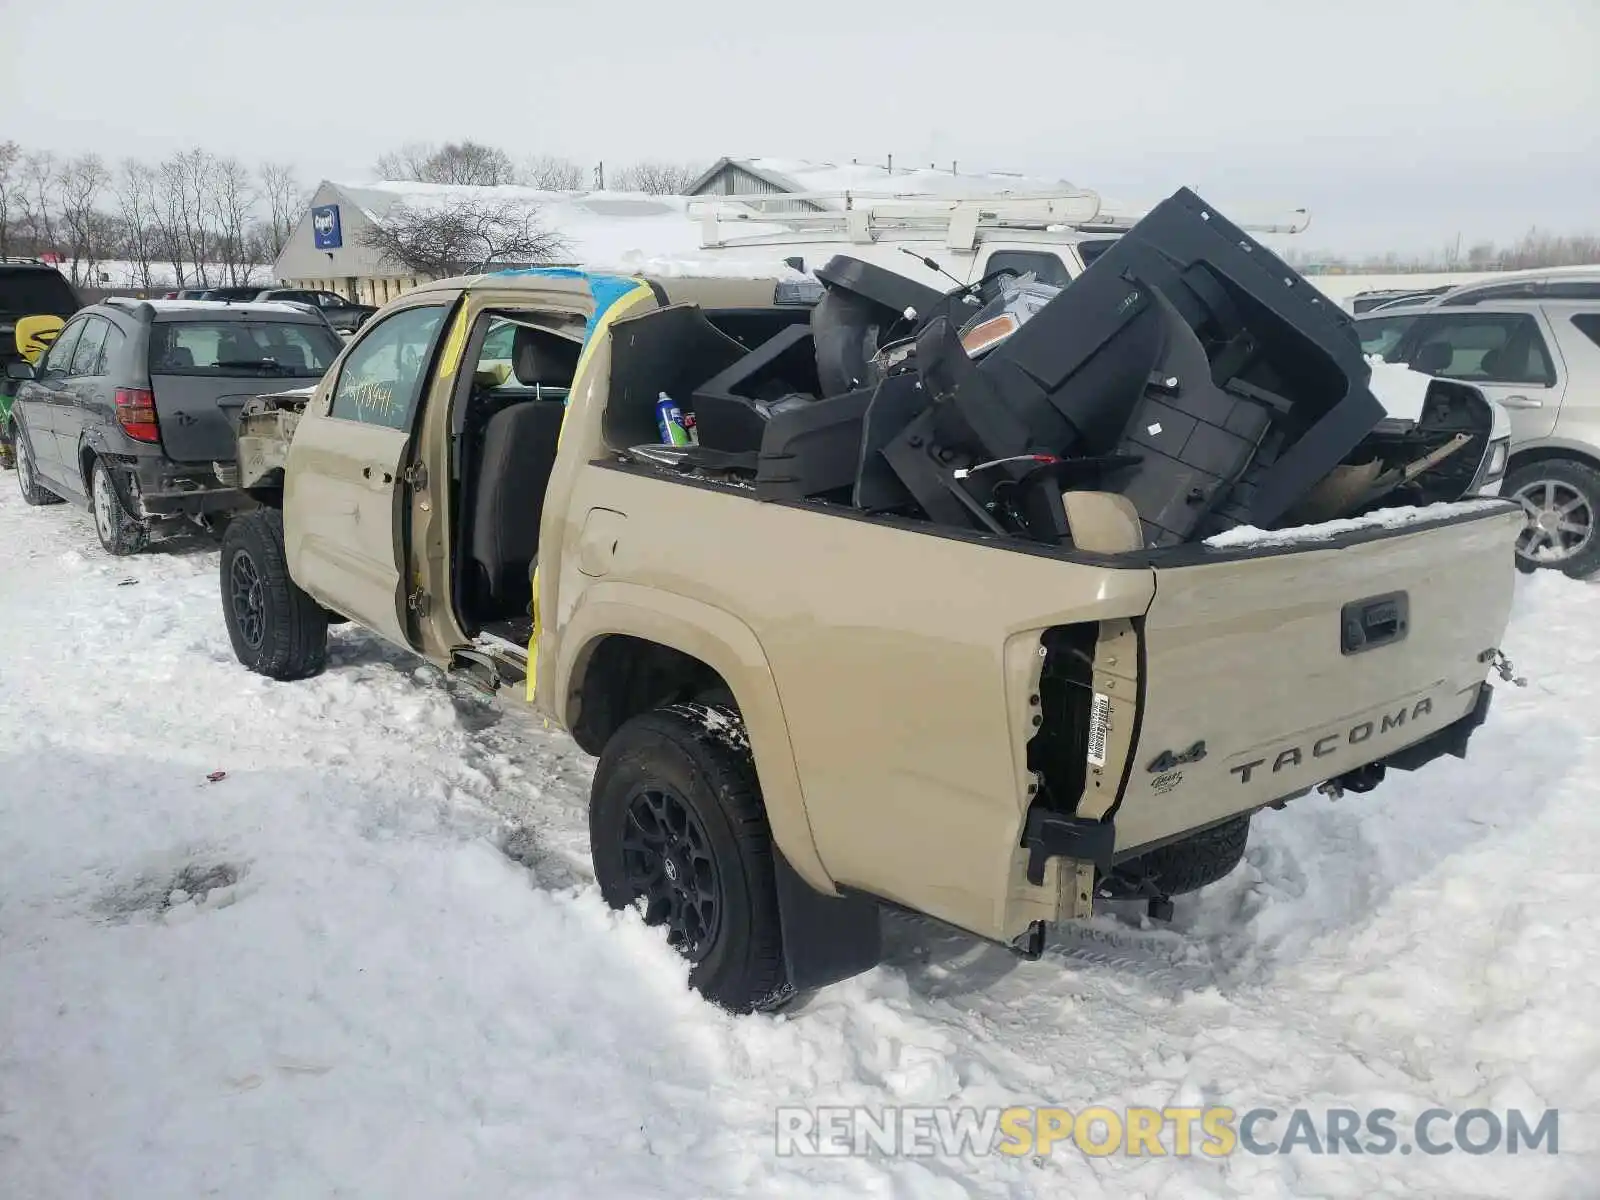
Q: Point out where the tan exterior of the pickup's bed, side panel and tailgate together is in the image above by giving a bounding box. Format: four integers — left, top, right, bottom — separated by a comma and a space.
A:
556, 461, 1522, 939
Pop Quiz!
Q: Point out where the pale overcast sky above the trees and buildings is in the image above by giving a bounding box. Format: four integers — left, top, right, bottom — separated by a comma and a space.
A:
0, 0, 1600, 251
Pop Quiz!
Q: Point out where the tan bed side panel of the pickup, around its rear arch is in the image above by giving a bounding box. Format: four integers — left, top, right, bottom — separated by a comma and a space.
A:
569, 467, 1154, 938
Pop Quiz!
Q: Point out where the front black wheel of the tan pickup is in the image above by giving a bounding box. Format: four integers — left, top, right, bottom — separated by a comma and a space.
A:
222, 509, 328, 680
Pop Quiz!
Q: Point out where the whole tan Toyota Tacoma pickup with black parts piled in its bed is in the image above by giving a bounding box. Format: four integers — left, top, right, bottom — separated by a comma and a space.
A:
221, 192, 1522, 1010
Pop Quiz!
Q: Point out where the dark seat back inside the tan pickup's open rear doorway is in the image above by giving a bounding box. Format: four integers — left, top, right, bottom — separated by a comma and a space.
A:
470, 400, 566, 619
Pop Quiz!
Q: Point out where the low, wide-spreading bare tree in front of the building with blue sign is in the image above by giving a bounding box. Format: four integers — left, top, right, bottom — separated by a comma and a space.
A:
362, 200, 566, 278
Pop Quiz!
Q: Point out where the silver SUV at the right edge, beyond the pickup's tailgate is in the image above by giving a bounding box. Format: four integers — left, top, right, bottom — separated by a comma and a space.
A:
1355, 291, 1600, 579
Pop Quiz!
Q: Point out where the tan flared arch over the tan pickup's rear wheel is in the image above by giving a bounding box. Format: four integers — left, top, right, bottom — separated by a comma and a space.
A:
553, 582, 837, 896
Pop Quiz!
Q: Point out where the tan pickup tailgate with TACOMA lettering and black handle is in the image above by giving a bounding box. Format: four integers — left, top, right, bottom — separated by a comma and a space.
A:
1114, 506, 1523, 856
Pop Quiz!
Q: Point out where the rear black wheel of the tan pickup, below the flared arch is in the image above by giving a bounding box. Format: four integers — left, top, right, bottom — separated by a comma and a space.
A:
589, 702, 790, 1013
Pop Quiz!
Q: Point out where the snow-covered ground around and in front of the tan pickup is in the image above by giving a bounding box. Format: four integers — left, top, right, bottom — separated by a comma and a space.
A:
0, 477, 1600, 1200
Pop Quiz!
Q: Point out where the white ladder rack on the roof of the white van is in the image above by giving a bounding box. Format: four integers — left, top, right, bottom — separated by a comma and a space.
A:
688, 189, 1310, 253
